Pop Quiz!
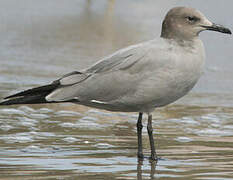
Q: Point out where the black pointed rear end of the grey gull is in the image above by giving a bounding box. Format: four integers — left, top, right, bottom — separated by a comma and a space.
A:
0, 82, 60, 105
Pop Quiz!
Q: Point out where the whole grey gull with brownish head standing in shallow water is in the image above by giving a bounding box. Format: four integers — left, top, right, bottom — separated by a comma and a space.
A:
0, 7, 231, 160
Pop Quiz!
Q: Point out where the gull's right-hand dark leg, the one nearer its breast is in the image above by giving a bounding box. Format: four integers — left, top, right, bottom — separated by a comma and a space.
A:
147, 114, 157, 160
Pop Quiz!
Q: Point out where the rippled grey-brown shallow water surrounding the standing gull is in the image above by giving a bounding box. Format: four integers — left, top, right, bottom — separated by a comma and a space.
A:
0, 0, 233, 180
